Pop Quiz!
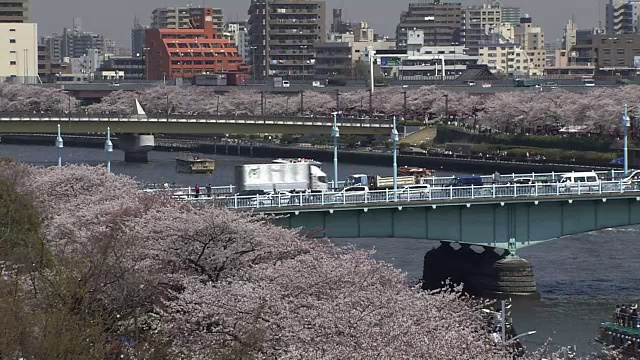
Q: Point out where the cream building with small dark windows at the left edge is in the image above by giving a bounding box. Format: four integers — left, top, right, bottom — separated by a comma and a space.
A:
0, 23, 38, 84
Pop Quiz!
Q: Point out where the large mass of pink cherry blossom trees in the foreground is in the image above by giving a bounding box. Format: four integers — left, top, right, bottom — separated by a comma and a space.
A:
0, 164, 520, 359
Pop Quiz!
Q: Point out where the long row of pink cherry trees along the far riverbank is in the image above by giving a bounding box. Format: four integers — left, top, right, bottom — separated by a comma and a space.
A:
5, 85, 640, 131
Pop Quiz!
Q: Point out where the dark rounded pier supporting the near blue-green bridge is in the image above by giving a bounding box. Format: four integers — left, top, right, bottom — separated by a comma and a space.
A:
422, 242, 539, 298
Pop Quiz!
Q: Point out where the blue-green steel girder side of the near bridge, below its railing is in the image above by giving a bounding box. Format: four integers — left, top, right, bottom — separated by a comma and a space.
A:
266, 192, 640, 252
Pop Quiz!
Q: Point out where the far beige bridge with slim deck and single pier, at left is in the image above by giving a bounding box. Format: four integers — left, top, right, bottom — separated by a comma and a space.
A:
0, 113, 392, 162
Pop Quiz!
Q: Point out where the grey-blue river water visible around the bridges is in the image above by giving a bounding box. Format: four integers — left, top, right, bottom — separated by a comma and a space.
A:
0, 144, 640, 354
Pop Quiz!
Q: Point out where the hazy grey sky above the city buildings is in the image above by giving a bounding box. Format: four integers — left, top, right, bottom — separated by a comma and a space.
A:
30, 0, 605, 48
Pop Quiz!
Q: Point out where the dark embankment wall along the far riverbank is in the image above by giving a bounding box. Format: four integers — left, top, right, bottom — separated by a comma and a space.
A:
1, 135, 611, 174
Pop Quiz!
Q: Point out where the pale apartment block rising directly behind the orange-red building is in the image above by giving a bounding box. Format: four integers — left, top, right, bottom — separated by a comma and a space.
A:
151, 7, 224, 37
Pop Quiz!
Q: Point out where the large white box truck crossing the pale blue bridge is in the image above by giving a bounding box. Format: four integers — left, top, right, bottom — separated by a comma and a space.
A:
235, 163, 329, 193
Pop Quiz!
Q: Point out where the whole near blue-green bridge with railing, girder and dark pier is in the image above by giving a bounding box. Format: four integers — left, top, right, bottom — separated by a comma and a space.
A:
162, 171, 640, 295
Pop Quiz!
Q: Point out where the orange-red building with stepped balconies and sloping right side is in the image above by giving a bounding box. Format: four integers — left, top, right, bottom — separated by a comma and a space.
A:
145, 8, 249, 80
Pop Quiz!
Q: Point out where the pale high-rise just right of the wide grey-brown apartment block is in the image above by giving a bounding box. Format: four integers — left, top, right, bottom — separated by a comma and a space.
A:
463, 4, 502, 56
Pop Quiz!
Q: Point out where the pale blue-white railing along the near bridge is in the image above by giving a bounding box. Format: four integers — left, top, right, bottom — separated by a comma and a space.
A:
149, 181, 640, 209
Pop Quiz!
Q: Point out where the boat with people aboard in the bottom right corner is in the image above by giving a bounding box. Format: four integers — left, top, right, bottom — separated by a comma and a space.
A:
595, 304, 640, 359
